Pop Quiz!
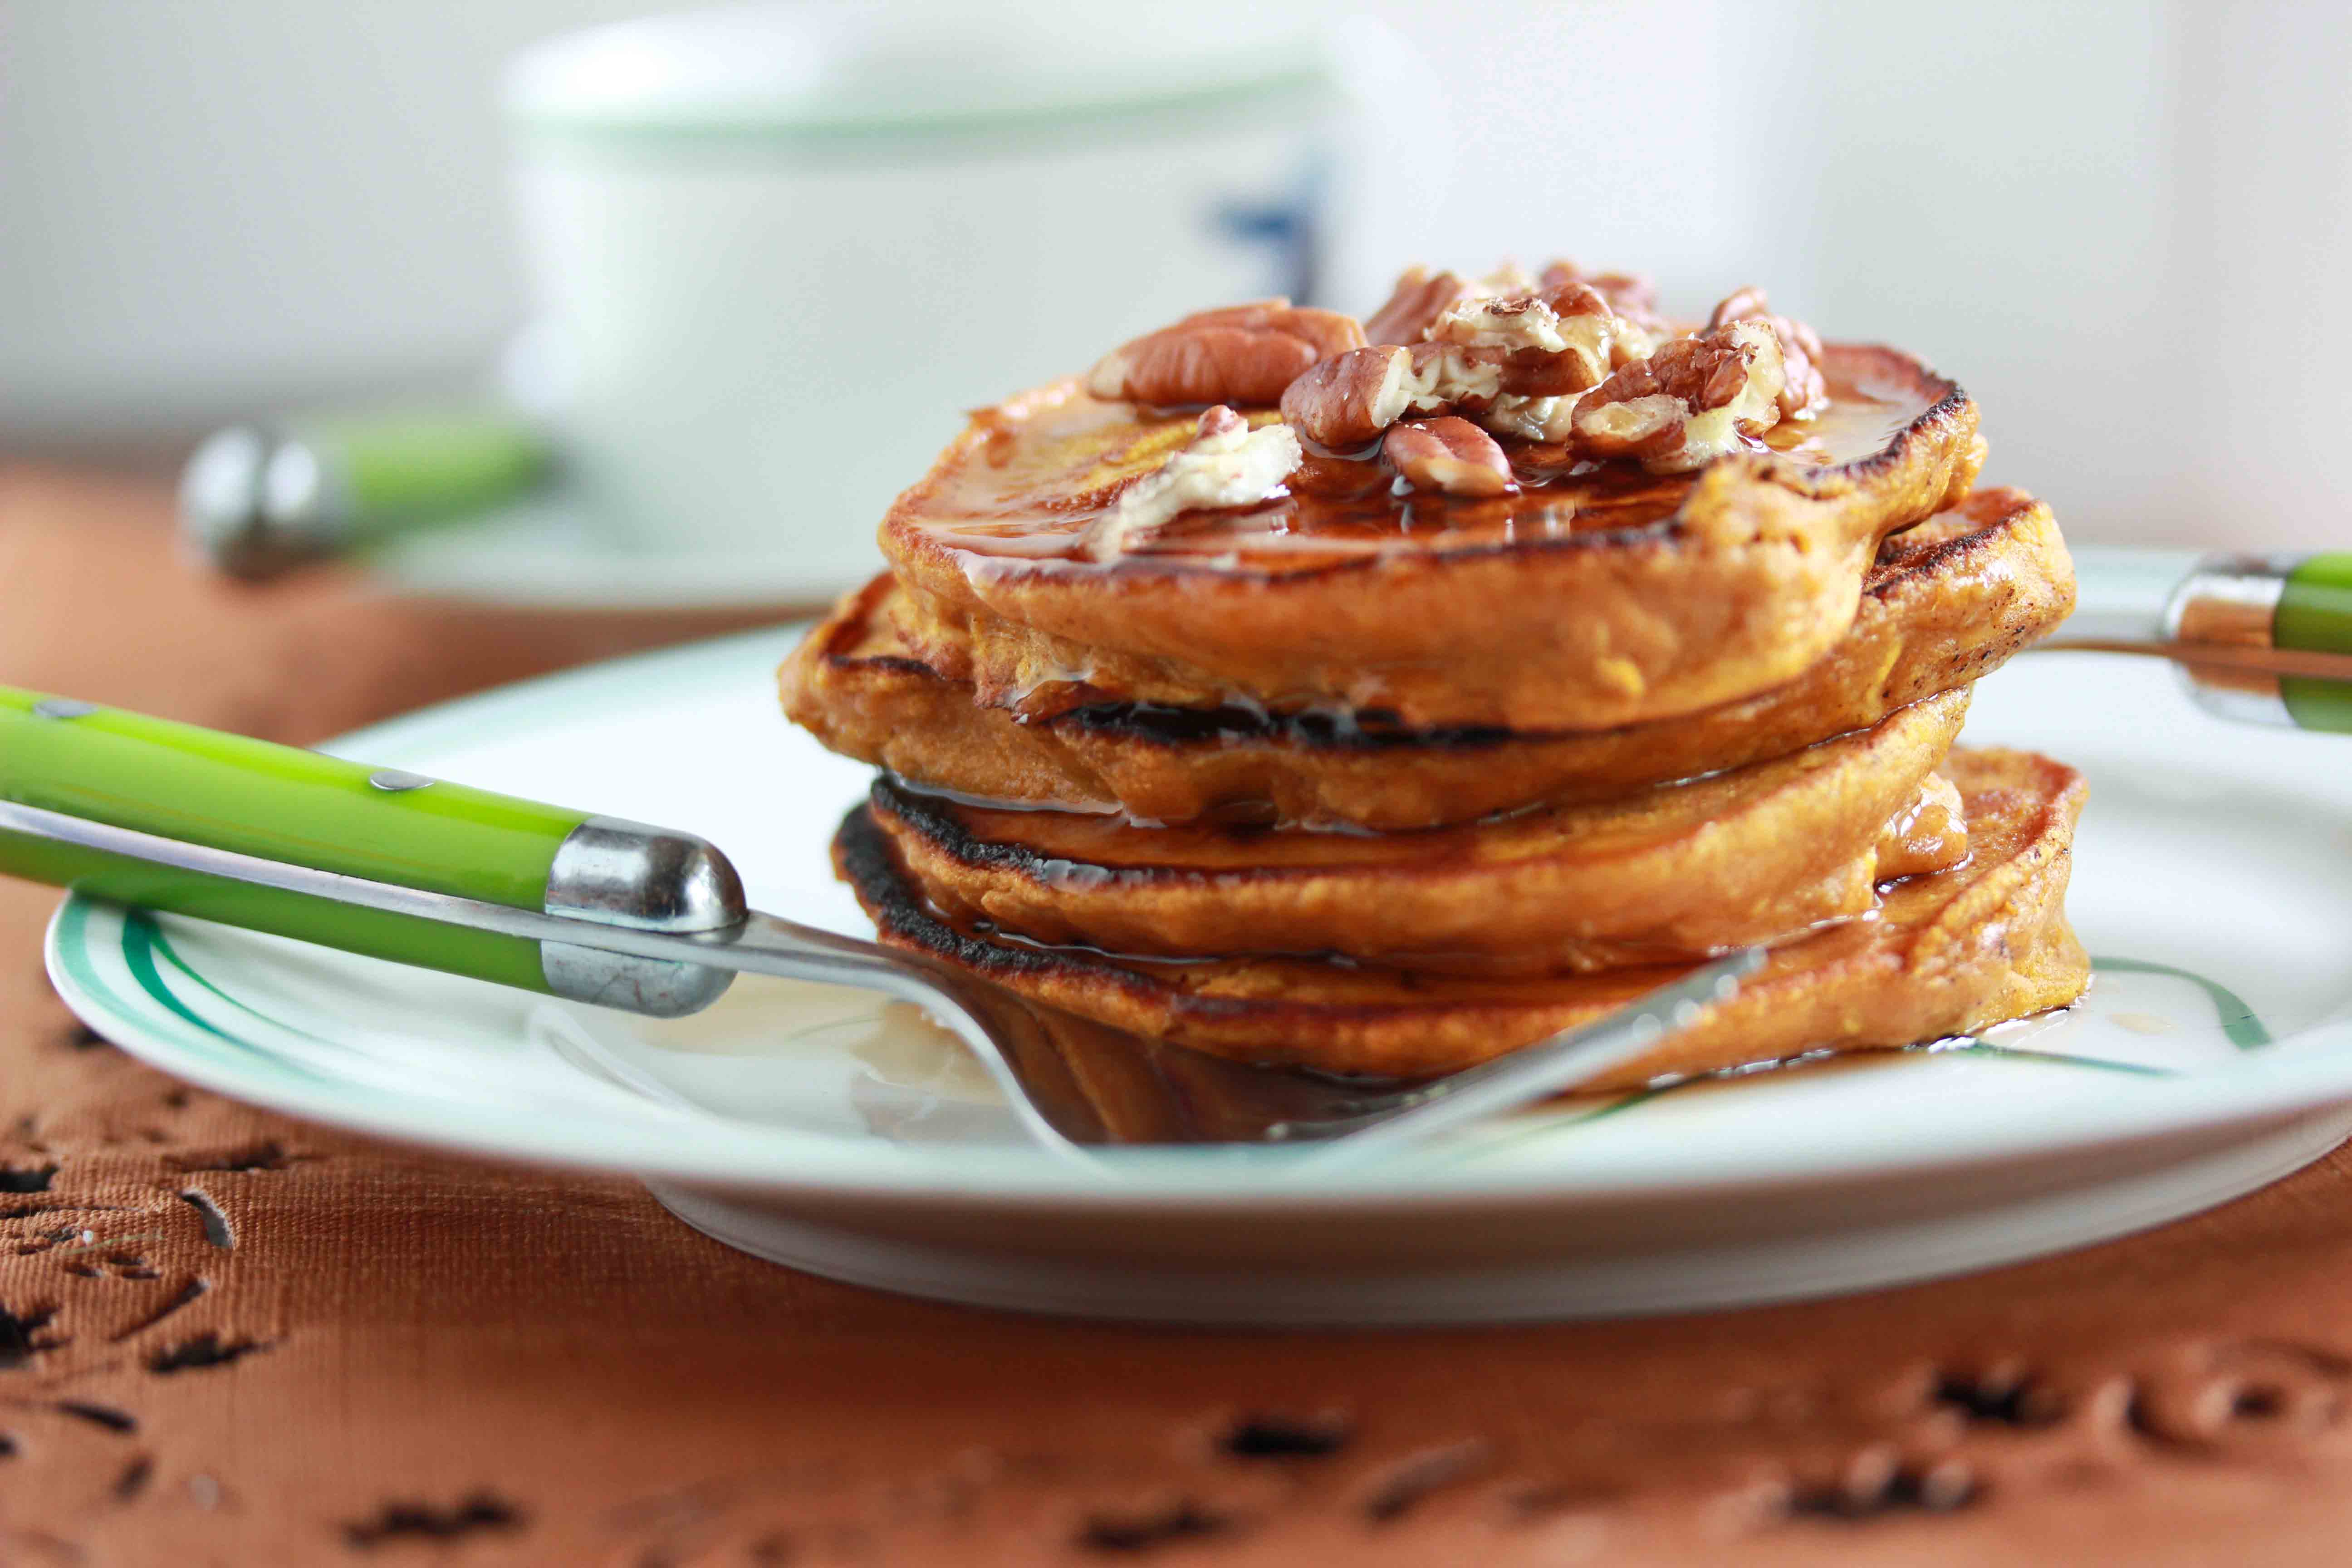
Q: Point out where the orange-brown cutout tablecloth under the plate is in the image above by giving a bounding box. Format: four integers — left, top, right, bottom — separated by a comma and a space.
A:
0, 456, 2352, 1568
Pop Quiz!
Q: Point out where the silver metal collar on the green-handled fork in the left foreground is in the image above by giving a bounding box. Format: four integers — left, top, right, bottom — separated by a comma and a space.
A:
539, 816, 750, 1018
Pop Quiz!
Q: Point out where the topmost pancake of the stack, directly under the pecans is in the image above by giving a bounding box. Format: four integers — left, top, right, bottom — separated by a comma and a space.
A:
880, 346, 1983, 731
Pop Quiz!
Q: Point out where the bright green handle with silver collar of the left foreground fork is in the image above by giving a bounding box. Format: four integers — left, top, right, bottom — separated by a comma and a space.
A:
0, 686, 743, 1011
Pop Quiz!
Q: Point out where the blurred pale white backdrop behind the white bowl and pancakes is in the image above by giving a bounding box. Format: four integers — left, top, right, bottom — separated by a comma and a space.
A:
0, 0, 2352, 545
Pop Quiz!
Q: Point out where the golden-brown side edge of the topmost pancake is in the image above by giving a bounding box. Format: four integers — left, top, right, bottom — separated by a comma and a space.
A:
880, 346, 1983, 731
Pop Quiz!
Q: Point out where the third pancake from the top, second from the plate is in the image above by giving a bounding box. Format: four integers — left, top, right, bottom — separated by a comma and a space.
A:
870, 691, 1969, 975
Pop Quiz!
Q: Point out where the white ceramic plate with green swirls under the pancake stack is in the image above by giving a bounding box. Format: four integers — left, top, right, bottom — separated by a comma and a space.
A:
49, 597, 2352, 1321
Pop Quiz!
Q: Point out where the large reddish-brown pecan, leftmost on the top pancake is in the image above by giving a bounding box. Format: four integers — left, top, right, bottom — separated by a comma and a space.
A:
1087, 299, 1364, 407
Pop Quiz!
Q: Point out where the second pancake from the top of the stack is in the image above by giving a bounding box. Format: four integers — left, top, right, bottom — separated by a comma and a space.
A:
781, 489, 2074, 832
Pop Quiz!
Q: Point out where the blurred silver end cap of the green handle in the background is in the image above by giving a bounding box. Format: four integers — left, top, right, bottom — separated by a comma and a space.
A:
179, 426, 353, 578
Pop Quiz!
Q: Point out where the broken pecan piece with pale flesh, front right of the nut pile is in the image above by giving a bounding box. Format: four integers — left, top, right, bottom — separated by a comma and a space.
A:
1571, 322, 1788, 472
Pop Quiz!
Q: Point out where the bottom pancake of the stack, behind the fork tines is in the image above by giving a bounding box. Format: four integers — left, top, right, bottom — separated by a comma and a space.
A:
835, 750, 2088, 1088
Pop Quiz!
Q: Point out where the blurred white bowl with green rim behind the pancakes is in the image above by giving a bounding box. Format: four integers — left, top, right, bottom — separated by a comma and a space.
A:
506, 5, 1383, 585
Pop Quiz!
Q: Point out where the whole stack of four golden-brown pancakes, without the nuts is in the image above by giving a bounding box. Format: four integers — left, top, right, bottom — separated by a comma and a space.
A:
783, 261, 2088, 1084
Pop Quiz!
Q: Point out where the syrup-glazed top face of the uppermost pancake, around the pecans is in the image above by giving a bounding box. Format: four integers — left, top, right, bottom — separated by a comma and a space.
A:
912, 346, 1952, 576
